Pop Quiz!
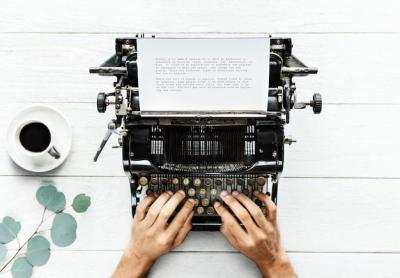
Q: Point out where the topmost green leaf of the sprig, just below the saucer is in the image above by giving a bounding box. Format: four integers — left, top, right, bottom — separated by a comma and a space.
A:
36, 185, 66, 212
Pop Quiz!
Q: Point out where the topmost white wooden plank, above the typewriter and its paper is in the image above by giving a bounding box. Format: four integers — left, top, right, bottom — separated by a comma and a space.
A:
0, 0, 399, 32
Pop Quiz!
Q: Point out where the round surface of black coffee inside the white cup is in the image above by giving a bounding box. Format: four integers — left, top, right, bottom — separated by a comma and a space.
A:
19, 122, 51, 152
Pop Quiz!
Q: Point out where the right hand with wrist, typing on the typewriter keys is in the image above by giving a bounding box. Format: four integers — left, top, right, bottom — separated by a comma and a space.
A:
214, 191, 296, 277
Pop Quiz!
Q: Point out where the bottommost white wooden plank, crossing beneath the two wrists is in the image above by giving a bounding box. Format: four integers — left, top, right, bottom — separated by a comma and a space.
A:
2, 251, 400, 278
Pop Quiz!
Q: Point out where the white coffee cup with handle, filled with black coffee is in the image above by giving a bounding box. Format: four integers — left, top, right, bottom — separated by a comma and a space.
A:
15, 120, 61, 160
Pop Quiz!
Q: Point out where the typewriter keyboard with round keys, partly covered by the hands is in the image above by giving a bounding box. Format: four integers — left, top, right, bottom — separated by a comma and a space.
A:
138, 175, 268, 218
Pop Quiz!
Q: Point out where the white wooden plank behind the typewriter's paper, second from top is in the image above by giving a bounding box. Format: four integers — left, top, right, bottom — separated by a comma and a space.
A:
0, 33, 400, 105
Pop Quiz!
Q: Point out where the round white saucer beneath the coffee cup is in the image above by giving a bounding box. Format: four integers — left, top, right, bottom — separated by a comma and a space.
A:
6, 105, 72, 173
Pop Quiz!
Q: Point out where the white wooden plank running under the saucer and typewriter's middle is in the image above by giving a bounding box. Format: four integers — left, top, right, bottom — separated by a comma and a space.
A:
0, 102, 400, 178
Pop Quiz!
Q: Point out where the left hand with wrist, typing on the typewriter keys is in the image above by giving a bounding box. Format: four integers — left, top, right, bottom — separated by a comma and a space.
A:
113, 190, 194, 277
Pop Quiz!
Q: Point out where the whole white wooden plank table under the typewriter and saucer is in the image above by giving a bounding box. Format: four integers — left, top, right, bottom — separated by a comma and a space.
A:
0, 0, 400, 278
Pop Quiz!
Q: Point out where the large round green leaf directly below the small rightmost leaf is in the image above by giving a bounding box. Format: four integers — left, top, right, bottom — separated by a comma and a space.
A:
51, 213, 78, 247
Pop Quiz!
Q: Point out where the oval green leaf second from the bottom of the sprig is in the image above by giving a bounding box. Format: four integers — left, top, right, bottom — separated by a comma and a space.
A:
26, 236, 50, 266
